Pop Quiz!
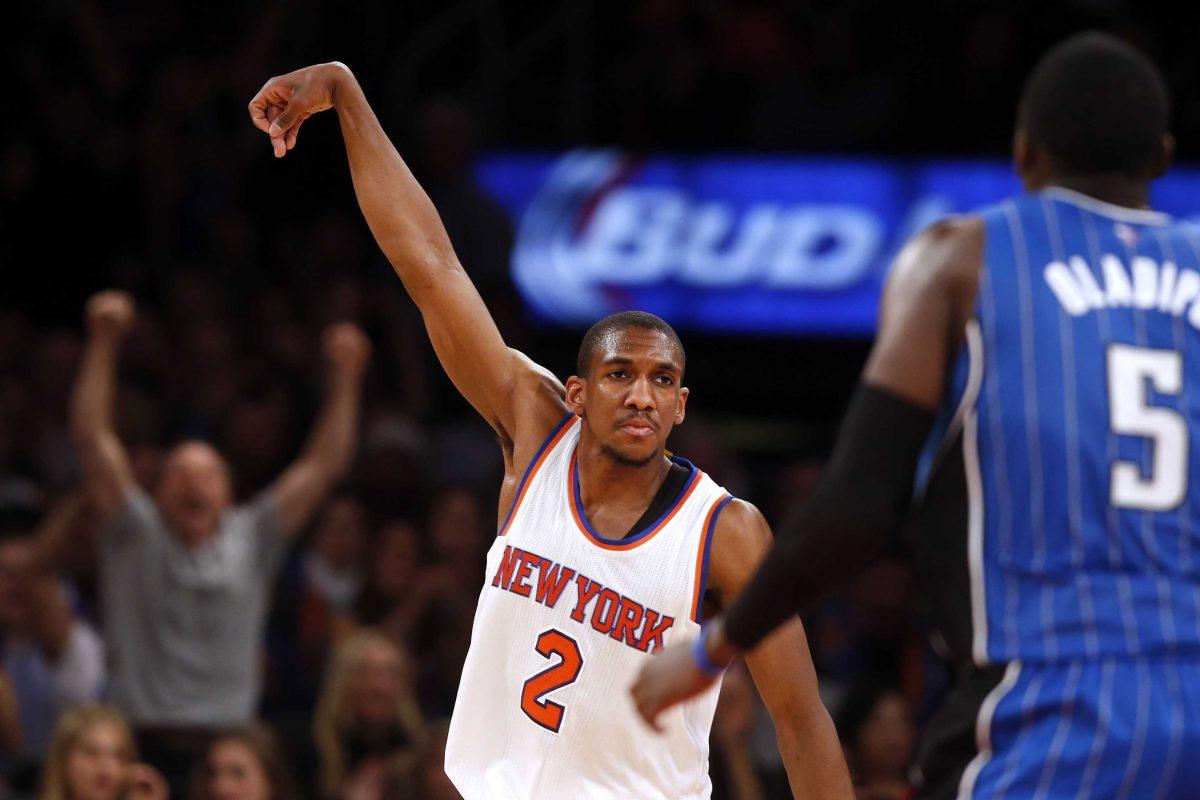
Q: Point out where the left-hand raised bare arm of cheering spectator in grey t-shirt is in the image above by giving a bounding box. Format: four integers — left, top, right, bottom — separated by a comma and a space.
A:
71, 290, 134, 518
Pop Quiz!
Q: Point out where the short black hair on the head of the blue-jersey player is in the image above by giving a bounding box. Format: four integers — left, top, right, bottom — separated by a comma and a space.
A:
1018, 31, 1170, 179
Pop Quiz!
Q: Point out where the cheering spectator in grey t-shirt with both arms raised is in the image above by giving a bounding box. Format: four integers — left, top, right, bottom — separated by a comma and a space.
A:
71, 290, 370, 795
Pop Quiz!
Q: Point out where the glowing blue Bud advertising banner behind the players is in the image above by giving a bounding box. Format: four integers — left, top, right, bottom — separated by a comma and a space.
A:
478, 150, 1200, 336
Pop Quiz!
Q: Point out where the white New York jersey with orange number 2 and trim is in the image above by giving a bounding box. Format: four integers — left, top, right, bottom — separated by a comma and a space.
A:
446, 415, 731, 800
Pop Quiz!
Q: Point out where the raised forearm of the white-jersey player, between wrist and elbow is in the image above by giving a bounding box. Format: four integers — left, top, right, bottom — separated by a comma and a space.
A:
334, 67, 462, 306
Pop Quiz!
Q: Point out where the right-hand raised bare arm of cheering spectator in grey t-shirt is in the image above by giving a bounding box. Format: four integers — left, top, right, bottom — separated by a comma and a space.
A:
271, 323, 371, 534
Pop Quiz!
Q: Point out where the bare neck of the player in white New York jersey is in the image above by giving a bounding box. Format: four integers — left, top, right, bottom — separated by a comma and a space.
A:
576, 437, 671, 537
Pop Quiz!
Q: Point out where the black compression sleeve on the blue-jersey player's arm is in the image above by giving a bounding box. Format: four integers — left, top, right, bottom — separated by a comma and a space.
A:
725, 384, 934, 650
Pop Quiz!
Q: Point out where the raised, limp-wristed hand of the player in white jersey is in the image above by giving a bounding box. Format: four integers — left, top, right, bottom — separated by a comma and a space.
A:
250, 61, 353, 158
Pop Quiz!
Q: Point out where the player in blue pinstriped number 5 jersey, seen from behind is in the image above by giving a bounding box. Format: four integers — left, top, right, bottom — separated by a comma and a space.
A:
635, 34, 1200, 800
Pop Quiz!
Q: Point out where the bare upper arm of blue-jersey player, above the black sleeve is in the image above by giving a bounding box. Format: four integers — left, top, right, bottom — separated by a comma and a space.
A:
863, 219, 983, 409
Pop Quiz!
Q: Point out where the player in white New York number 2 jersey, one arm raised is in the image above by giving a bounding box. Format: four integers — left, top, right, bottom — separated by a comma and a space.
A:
250, 64, 852, 800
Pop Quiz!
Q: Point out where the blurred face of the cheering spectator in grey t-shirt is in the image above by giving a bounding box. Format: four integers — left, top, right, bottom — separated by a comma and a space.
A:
156, 441, 233, 546
